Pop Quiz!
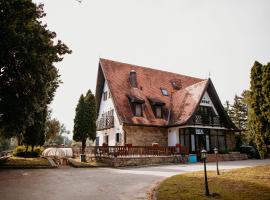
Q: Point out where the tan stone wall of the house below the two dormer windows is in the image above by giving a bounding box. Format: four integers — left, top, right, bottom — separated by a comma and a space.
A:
124, 126, 168, 146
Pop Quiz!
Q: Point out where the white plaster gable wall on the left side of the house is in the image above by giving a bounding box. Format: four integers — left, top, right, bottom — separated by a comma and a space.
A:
97, 81, 124, 146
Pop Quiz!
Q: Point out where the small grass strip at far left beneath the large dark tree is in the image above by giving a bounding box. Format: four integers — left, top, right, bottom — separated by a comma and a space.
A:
0, 156, 51, 168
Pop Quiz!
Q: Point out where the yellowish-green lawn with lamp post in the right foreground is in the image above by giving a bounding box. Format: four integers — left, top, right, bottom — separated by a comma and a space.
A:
156, 165, 270, 200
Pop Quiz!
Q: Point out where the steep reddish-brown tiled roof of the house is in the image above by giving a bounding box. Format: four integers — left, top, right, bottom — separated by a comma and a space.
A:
96, 59, 208, 126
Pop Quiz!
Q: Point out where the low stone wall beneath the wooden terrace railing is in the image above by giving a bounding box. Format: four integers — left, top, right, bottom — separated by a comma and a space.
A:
95, 156, 182, 167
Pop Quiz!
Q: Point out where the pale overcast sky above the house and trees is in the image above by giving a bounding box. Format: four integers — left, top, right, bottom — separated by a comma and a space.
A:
34, 0, 270, 134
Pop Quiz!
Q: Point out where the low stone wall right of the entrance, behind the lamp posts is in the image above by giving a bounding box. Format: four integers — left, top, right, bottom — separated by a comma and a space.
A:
207, 152, 248, 162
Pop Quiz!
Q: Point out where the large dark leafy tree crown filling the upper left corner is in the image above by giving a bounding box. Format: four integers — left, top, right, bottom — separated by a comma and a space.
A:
0, 0, 70, 143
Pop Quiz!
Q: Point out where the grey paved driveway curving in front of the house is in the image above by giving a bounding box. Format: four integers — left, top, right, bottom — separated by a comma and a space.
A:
0, 159, 270, 200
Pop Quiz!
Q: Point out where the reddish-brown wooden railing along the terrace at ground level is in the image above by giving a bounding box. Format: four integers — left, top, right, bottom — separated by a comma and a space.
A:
73, 146, 188, 157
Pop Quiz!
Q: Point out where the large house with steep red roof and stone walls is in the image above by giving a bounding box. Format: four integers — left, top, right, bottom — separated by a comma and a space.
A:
96, 59, 237, 153
